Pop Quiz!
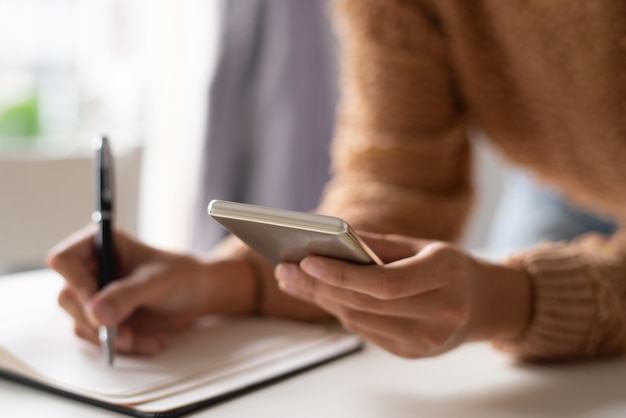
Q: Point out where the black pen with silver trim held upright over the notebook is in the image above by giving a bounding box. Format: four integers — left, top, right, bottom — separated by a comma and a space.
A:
92, 136, 117, 366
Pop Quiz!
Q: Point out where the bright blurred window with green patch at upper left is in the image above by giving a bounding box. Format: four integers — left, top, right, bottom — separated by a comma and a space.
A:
0, 0, 149, 150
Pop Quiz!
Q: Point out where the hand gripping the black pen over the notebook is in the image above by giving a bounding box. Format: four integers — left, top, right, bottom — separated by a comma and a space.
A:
47, 226, 256, 354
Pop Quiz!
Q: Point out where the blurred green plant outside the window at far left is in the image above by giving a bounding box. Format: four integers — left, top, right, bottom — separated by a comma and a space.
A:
0, 93, 41, 145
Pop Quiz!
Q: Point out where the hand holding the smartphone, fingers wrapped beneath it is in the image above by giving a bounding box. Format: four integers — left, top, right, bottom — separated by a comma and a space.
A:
275, 234, 531, 358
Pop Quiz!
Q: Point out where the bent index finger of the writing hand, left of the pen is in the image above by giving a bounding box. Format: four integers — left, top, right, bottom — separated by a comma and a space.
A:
47, 225, 98, 302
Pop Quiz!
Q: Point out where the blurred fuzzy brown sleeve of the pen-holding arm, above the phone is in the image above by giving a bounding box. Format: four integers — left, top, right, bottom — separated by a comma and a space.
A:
318, 0, 472, 240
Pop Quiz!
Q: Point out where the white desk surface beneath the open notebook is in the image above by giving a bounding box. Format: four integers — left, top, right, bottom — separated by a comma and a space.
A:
0, 272, 626, 418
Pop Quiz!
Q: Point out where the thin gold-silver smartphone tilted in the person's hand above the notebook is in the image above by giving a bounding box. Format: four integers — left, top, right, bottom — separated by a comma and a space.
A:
208, 200, 383, 264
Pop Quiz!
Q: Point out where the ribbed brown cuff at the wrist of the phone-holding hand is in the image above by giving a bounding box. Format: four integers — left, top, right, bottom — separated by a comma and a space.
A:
494, 245, 596, 359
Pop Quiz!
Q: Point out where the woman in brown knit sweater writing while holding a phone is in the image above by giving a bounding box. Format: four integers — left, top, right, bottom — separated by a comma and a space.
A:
49, 0, 626, 359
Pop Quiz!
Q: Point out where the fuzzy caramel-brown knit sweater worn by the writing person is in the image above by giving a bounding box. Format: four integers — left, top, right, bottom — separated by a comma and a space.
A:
319, 0, 626, 358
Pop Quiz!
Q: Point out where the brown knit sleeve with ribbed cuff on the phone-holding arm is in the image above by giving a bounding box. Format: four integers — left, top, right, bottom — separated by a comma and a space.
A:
495, 230, 626, 360
